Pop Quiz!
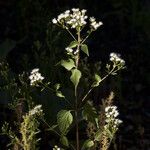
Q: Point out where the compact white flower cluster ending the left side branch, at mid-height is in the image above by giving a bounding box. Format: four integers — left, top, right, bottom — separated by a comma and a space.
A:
29, 68, 44, 85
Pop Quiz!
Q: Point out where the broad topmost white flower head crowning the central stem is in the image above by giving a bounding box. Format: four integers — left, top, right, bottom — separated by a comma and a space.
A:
52, 8, 102, 30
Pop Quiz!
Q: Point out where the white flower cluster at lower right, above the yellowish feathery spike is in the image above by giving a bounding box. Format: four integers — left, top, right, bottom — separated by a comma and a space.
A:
104, 106, 122, 130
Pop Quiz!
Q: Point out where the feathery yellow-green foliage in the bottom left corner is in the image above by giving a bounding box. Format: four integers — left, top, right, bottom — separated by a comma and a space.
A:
2, 105, 43, 150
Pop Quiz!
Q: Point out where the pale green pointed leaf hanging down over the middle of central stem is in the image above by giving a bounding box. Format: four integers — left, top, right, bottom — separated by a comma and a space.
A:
70, 69, 81, 87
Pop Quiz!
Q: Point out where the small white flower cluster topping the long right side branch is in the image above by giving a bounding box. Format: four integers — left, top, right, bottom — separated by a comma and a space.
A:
110, 52, 125, 65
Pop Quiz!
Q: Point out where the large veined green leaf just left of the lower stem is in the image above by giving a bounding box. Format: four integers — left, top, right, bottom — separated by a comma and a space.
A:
57, 110, 73, 134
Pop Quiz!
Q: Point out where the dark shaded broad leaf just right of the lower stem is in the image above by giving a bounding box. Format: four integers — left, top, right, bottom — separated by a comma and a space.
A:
82, 101, 98, 123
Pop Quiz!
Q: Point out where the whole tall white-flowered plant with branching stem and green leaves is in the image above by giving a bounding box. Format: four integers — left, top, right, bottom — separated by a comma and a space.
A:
29, 8, 125, 150
